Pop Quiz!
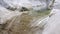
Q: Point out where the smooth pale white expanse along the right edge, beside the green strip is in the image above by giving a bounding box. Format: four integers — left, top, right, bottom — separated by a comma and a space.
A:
43, 0, 60, 34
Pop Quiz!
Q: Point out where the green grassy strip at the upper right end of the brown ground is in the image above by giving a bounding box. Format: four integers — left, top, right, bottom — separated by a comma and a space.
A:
31, 10, 51, 17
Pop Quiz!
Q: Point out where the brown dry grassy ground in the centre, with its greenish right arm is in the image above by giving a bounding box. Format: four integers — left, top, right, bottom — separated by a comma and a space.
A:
0, 9, 49, 34
